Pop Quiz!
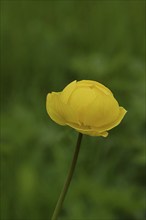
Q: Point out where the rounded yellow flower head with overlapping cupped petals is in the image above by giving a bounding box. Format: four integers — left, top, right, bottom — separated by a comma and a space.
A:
46, 80, 127, 137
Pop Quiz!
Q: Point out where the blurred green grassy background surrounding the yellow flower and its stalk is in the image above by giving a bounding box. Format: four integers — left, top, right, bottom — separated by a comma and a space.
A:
0, 0, 146, 220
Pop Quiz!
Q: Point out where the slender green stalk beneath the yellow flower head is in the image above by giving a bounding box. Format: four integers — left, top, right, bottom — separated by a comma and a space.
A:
51, 133, 83, 220
